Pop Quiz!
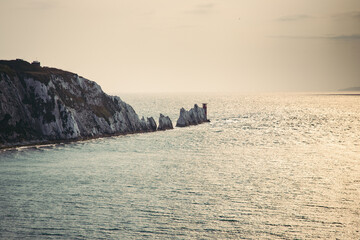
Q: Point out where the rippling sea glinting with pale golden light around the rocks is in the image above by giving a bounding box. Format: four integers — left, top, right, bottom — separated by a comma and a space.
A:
0, 93, 360, 239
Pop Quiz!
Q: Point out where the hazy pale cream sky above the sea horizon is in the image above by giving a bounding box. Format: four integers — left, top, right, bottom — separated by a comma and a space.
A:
0, 0, 360, 93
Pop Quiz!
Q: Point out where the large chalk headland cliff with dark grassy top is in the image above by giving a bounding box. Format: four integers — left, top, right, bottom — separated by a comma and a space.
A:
0, 60, 156, 147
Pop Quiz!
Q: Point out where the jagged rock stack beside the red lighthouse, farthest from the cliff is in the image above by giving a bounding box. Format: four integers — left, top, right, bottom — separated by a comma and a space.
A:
176, 104, 209, 127
